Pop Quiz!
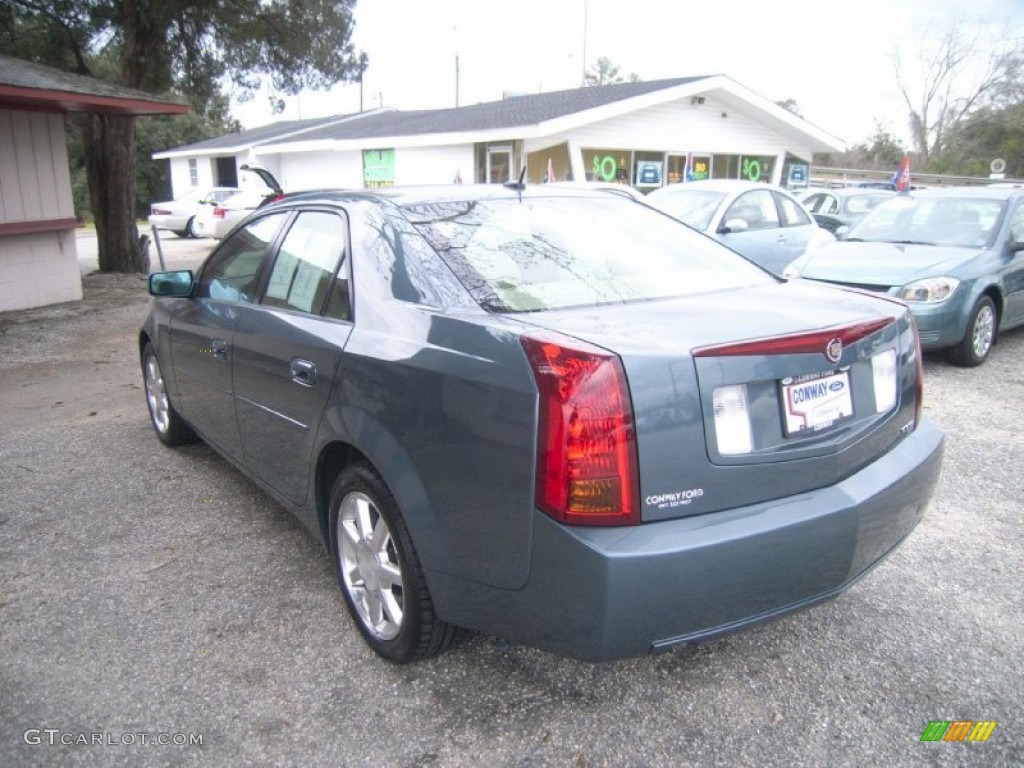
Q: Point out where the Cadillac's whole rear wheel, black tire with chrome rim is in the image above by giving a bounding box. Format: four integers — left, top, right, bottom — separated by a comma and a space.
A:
330, 464, 456, 664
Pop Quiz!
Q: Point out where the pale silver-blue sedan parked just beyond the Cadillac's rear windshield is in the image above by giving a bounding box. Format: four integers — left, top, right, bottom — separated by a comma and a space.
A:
647, 179, 836, 274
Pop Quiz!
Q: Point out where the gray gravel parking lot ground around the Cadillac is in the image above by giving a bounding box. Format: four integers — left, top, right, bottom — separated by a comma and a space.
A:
0, 236, 1024, 767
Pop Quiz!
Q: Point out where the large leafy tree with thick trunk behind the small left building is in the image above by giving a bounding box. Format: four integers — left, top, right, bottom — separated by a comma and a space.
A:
0, 0, 360, 271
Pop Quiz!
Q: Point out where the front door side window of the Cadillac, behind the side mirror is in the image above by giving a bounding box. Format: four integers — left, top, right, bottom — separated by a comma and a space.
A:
196, 213, 288, 303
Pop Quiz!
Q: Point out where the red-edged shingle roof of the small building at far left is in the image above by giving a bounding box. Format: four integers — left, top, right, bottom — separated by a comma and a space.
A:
0, 55, 182, 114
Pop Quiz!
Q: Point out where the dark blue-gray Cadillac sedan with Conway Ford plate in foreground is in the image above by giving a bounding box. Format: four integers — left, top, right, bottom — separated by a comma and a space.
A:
138, 185, 943, 662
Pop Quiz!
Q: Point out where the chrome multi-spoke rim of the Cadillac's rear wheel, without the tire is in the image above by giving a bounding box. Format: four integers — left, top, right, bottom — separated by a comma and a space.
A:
337, 492, 406, 640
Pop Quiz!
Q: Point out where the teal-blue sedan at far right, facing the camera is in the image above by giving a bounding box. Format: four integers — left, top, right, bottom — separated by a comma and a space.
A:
786, 186, 1024, 366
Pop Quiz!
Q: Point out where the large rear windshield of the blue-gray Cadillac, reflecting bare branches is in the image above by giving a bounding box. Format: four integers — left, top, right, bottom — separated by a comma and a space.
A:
403, 194, 773, 312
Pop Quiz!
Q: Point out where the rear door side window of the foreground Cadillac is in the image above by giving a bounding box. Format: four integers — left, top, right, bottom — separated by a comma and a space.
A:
263, 211, 350, 319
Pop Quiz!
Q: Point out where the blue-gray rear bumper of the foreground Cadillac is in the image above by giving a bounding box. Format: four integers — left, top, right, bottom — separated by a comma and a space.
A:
429, 419, 943, 662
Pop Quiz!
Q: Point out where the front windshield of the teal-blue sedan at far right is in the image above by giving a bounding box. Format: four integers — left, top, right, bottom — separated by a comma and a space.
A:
846, 195, 1006, 248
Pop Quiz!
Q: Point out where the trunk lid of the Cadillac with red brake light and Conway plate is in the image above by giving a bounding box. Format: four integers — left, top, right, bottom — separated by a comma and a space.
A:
518, 282, 918, 521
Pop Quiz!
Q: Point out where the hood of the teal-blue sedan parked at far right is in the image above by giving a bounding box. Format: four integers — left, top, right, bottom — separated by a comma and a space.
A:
797, 241, 979, 286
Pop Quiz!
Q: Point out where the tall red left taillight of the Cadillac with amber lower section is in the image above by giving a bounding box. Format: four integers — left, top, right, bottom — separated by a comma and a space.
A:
522, 335, 640, 525
